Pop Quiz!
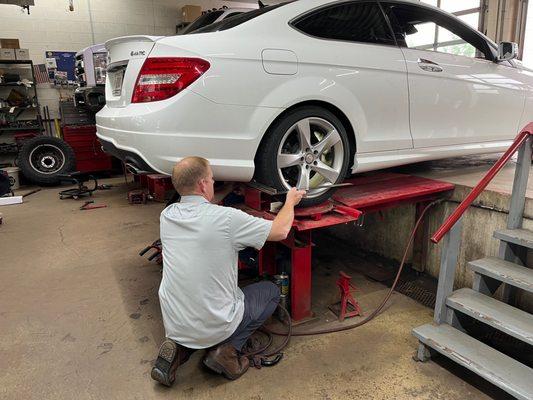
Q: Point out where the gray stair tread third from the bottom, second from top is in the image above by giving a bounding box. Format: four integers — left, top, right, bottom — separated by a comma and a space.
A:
468, 257, 533, 293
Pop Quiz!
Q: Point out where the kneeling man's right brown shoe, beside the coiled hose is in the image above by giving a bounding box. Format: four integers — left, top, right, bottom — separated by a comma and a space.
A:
204, 343, 250, 380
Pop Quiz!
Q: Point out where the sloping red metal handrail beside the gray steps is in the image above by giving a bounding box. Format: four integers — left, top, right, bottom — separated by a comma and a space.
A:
431, 122, 533, 243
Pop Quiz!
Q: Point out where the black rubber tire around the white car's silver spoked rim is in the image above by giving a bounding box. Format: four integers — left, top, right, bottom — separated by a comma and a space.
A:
255, 106, 352, 207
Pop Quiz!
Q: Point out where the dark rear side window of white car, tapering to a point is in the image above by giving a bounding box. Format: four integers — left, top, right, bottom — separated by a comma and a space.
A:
292, 2, 396, 45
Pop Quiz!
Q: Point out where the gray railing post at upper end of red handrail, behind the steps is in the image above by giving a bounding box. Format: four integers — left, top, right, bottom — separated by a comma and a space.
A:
499, 135, 533, 304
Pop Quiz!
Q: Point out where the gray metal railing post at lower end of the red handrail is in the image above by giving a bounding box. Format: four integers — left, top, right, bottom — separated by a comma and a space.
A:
433, 218, 463, 324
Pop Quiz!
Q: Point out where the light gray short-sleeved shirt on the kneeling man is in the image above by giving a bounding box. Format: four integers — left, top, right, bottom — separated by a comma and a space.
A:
159, 196, 272, 349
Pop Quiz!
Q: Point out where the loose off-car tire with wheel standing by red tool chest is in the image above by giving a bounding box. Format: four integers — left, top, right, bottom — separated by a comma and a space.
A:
17, 136, 76, 185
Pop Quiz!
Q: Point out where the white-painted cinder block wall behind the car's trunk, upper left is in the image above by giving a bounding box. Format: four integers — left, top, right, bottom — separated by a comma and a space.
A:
0, 0, 257, 117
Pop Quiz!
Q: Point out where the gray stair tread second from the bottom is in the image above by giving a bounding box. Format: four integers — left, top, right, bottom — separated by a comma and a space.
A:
446, 288, 533, 345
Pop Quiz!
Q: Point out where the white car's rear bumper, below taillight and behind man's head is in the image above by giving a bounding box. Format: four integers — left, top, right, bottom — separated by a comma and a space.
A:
96, 91, 278, 182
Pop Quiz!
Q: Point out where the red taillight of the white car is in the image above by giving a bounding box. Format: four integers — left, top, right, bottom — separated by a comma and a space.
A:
131, 57, 210, 103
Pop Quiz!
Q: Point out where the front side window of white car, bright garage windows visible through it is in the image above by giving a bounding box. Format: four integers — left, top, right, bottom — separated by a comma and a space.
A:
383, 3, 492, 59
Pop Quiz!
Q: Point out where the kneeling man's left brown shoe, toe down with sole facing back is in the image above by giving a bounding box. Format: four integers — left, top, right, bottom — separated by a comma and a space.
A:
151, 339, 194, 386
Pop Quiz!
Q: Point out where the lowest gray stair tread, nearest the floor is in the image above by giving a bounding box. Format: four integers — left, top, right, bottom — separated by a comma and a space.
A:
413, 324, 533, 400
